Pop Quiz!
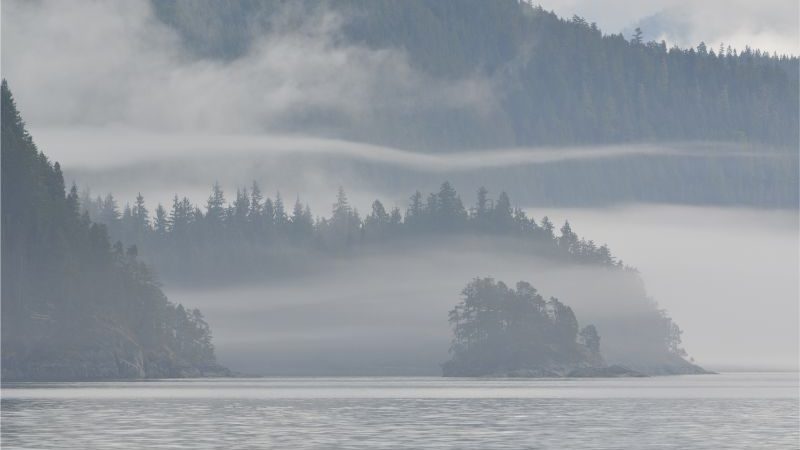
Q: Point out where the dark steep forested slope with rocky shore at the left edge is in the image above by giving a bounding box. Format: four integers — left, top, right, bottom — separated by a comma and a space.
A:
2, 80, 226, 380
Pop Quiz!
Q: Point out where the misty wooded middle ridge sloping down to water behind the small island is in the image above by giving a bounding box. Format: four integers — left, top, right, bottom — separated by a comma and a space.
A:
81, 182, 702, 374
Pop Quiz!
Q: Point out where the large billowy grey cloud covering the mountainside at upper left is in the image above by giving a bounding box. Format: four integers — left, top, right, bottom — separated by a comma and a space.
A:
2, 1, 494, 135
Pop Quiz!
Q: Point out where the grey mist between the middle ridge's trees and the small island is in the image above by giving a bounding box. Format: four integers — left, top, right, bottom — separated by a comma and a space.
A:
166, 238, 664, 375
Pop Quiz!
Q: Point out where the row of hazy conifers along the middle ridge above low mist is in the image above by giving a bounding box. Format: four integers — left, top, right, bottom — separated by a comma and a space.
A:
81, 182, 622, 282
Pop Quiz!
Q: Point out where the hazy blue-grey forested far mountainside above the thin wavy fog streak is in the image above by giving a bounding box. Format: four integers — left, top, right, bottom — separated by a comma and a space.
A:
152, 0, 800, 151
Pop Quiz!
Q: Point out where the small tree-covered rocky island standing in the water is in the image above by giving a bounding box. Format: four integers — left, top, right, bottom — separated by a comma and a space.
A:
442, 278, 644, 377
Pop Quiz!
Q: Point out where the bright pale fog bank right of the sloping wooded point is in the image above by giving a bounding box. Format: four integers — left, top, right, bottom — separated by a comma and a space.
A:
531, 205, 800, 370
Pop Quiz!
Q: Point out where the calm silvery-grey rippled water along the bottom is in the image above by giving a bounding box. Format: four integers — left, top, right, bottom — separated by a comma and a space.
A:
2, 373, 800, 449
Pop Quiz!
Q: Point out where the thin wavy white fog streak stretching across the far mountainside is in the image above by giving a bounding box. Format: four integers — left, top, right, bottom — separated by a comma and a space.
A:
34, 128, 685, 173
